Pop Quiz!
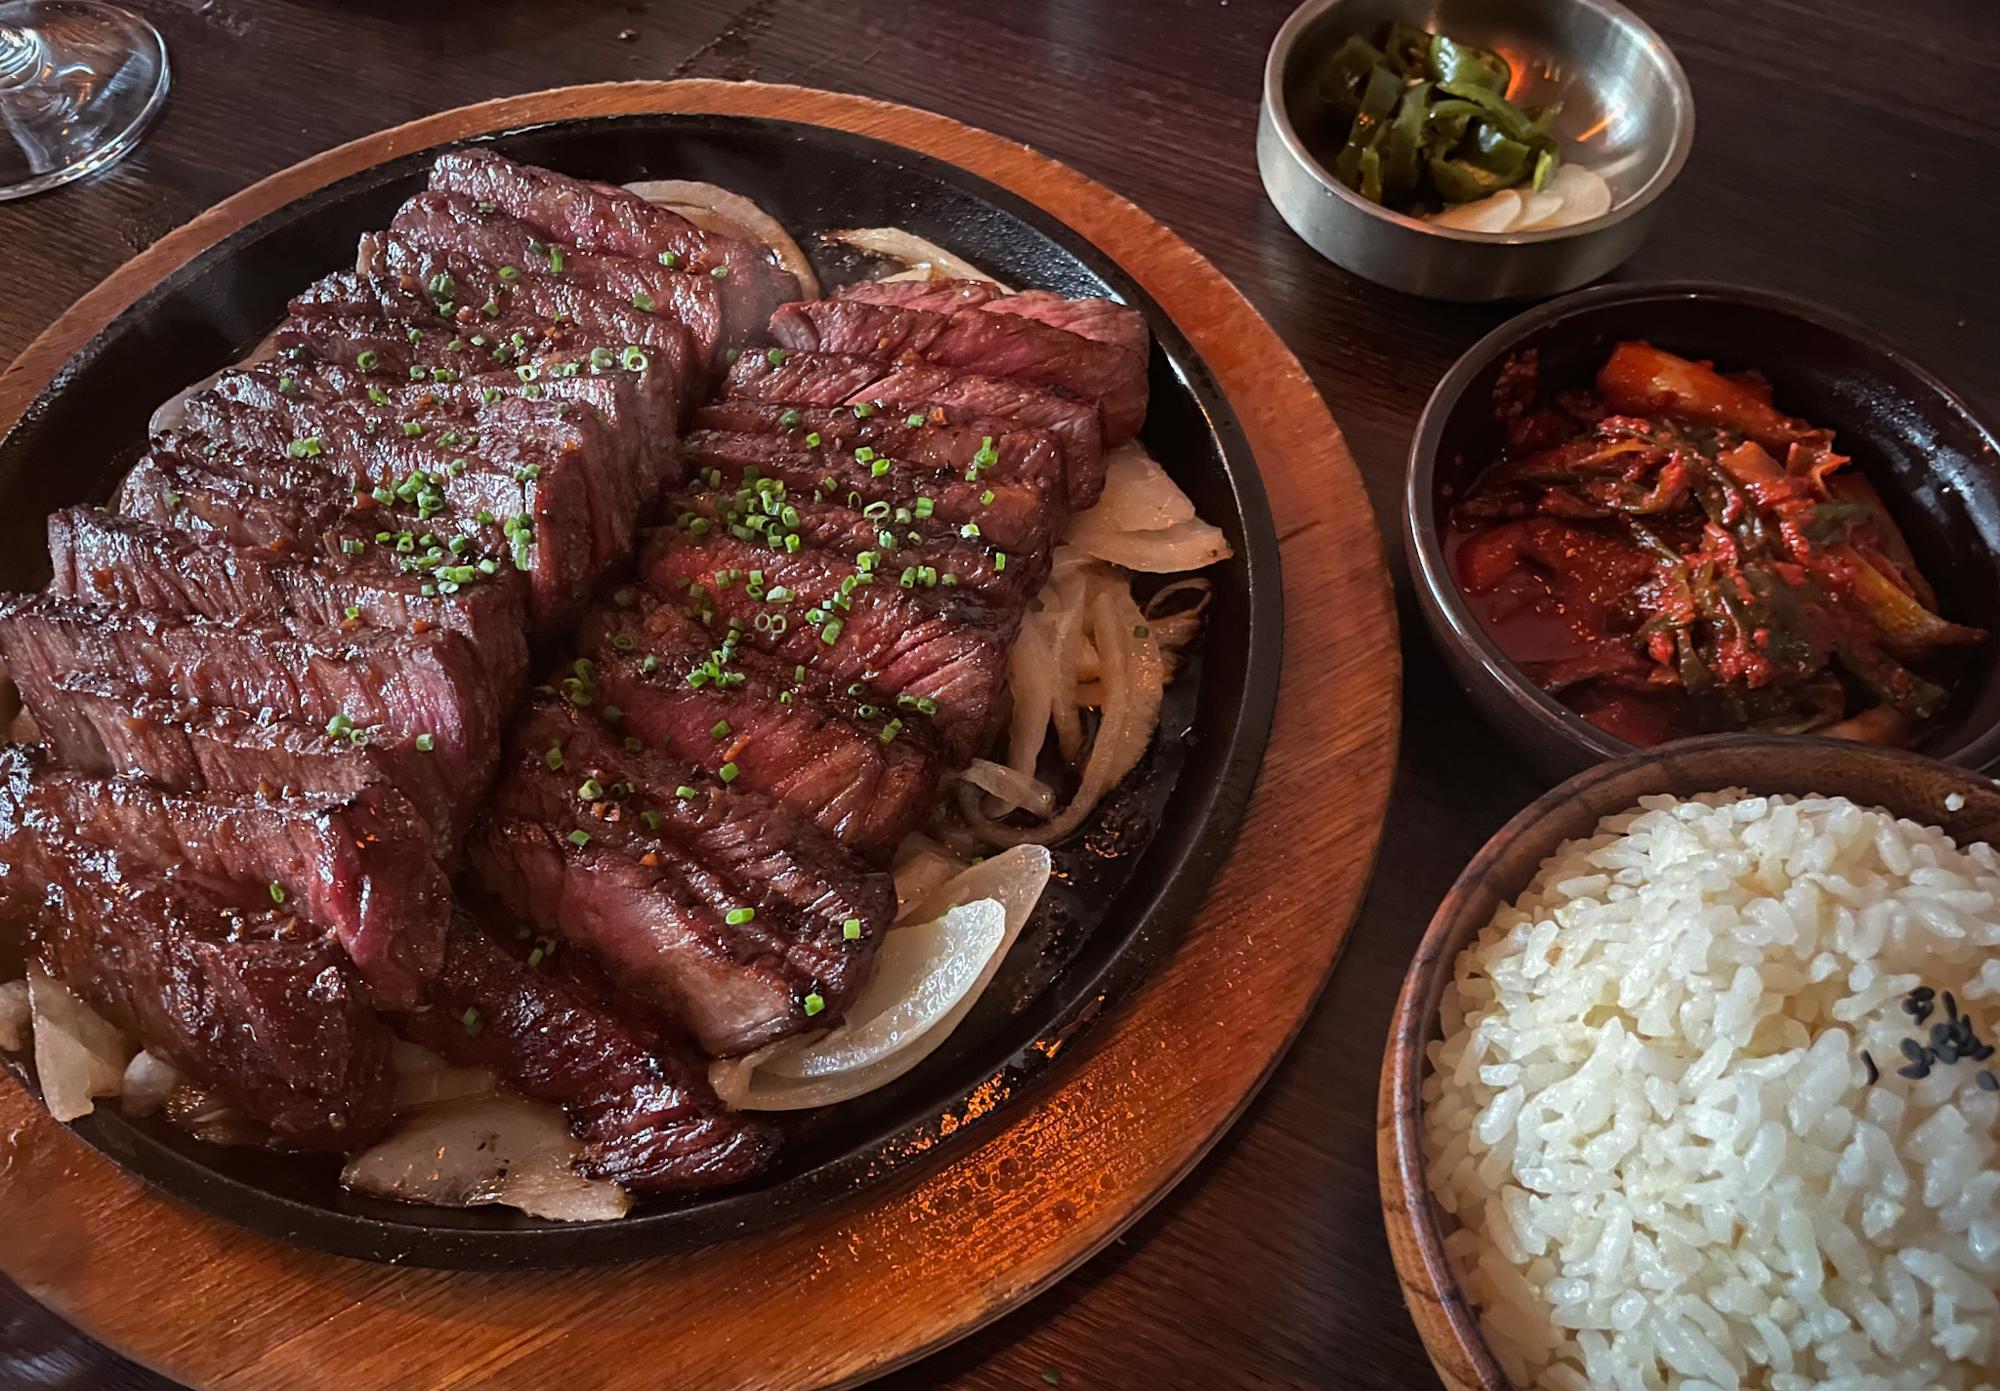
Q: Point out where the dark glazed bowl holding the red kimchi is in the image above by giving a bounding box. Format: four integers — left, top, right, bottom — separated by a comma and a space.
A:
1404, 284, 2000, 777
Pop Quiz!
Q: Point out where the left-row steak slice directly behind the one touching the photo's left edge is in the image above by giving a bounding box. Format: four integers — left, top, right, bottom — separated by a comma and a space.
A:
48, 508, 528, 690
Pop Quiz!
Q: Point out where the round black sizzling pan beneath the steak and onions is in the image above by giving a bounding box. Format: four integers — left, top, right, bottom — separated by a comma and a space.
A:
0, 116, 1282, 1269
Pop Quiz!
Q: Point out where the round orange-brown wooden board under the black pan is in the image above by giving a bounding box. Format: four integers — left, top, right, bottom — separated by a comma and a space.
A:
0, 82, 1400, 1391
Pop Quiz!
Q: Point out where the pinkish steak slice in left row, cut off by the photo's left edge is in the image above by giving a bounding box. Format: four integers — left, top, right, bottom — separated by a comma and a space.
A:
0, 598, 500, 835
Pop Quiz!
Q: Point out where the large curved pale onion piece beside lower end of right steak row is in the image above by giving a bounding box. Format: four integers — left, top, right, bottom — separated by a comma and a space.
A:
708, 845, 1054, 1111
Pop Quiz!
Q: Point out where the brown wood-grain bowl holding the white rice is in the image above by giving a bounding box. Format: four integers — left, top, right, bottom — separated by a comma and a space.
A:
1380, 733, 2000, 1391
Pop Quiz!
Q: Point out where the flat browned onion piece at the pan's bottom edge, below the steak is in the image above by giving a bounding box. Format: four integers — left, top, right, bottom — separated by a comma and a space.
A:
340, 1095, 632, 1221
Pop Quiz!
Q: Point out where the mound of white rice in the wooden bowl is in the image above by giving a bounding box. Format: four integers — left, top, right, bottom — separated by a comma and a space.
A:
1424, 791, 2000, 1391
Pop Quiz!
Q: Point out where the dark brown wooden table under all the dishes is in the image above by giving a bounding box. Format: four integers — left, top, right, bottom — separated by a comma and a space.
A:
0, 0, 2000, 1391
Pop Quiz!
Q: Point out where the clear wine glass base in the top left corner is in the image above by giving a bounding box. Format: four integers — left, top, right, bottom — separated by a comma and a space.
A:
0, 0, 168, 202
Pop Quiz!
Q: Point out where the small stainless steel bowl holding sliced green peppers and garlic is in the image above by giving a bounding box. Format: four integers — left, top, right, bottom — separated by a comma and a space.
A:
1256, 0, 1694, 300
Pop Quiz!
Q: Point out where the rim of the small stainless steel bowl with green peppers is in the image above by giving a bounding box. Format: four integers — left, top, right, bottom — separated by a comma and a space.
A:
1262, 0, 1694, 246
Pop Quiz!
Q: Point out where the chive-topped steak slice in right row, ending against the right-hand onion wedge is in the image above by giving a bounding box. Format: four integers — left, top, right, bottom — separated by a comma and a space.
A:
686, 402, 1068, 554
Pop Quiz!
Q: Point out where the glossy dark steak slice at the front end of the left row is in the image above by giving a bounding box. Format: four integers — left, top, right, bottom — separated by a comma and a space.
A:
16, 833, 394, 1149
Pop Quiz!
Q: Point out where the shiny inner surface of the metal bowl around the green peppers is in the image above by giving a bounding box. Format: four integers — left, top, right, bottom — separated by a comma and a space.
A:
1280, 0, 1688, 218
